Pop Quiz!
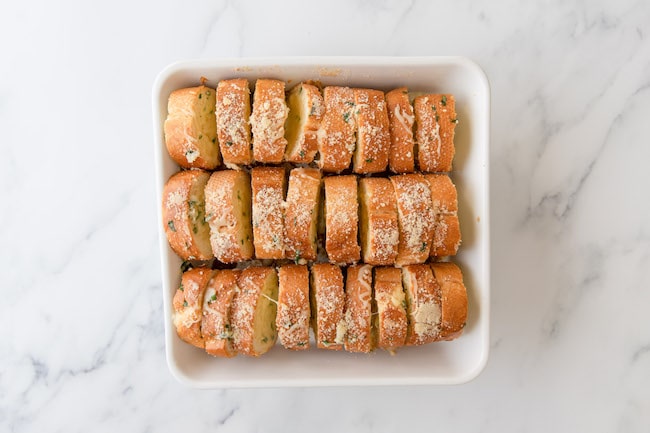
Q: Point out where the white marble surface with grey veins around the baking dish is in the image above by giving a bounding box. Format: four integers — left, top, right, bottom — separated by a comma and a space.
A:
0, 0, 650, 432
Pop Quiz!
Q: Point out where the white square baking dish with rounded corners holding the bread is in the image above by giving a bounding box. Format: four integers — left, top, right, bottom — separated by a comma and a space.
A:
153, 57, 490, 388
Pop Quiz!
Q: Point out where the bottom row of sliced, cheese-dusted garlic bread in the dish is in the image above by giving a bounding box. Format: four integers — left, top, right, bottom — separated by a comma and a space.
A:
173, 262, 467, 357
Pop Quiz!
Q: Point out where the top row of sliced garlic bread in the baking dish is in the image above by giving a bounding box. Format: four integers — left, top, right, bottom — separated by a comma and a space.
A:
165, 78, 458, 173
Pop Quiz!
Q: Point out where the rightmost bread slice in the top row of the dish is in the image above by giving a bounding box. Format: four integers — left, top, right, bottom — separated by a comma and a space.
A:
413, 94, 458, 172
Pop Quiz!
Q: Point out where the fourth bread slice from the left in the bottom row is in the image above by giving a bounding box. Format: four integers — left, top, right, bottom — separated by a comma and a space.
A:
275, 265, 311, 350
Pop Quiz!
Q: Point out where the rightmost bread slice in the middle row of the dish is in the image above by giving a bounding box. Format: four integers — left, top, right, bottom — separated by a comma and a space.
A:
425, 174, 461, 257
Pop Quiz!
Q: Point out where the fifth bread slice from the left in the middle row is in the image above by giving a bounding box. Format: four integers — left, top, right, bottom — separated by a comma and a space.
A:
323, 175, 361, 264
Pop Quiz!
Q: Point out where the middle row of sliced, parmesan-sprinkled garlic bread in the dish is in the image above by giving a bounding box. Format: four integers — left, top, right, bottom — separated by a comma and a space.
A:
162, 167, 461, 266
